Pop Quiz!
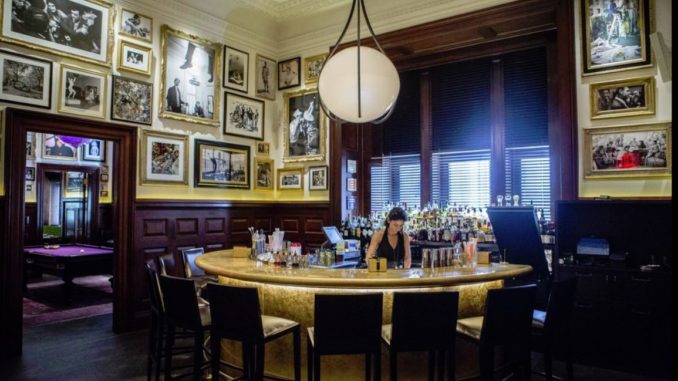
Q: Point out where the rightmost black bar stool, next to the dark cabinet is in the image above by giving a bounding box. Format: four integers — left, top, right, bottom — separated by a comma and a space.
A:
531, 277, 577, 381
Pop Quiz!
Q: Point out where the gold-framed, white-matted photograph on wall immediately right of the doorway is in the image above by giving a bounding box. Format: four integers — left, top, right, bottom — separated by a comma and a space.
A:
140, 130, 188, 185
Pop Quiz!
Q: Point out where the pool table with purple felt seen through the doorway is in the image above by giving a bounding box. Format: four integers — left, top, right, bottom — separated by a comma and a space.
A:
24, 244, 113, 300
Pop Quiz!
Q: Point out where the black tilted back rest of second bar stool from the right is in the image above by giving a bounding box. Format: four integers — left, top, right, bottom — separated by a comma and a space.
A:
480, 284, 537, 346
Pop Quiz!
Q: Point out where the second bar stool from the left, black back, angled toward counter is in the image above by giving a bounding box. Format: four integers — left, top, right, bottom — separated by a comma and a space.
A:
160, 275, 210, 381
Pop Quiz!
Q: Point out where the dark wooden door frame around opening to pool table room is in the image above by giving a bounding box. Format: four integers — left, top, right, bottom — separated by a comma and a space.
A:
0, 108, 138, 359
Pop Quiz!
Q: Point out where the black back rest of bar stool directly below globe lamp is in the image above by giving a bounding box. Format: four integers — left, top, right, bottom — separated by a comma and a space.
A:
314, 294, 384, 355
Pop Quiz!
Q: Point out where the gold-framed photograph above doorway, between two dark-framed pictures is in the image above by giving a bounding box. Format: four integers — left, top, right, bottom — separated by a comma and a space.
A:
59, 64, 106, 119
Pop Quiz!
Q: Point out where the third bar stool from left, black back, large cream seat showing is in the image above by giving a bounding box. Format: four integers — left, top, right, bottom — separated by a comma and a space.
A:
207, 283, 301, 381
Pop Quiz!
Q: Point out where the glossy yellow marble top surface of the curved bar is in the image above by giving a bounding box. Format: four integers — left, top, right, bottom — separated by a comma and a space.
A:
195, 250, 532, 288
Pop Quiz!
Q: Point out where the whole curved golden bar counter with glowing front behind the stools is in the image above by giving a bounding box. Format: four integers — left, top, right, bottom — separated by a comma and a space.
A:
196, 250, 532, 380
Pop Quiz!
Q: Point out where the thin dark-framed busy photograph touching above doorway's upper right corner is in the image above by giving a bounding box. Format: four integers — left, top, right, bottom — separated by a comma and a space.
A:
111, 75, 153, 126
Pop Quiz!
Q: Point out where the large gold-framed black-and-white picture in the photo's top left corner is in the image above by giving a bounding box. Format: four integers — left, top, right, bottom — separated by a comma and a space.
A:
0, 0, 115, 67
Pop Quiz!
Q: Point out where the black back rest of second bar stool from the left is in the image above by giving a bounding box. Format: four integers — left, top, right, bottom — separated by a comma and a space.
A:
160, 275, 202, 329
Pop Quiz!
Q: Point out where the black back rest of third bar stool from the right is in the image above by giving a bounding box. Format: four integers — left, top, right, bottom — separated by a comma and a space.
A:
391, 291, 459, 351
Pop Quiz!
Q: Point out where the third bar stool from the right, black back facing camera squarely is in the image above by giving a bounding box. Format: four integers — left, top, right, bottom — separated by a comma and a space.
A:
381, 291, 459, 381
